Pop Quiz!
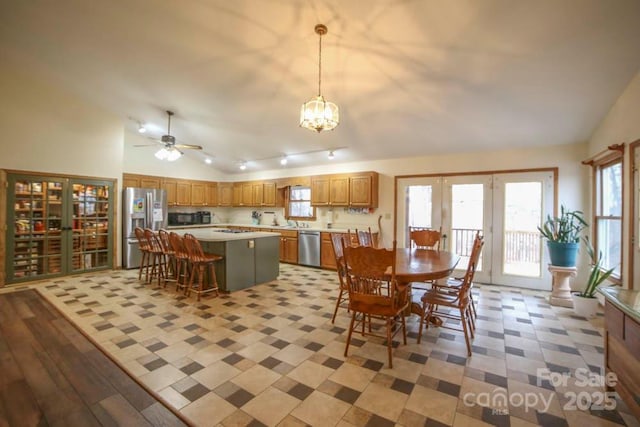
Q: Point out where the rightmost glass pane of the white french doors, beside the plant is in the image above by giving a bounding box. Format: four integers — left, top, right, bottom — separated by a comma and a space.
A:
502, 182, 543, 277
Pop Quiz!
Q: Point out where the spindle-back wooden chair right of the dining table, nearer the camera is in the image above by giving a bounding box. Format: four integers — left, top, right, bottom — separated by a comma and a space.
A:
418, 232, 484, 356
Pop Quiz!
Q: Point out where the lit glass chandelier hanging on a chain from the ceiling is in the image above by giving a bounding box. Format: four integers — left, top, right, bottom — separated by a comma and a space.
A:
300, 24, 340, 132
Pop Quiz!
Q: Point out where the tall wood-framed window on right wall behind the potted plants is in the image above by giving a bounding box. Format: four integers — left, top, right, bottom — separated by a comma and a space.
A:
593, 156, 622, 278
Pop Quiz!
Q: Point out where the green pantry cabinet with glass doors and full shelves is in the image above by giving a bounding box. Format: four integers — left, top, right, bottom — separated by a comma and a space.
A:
5, 173, 114, 283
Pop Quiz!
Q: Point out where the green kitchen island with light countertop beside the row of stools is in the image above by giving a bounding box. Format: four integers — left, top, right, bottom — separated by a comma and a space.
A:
171, 227, 280, 292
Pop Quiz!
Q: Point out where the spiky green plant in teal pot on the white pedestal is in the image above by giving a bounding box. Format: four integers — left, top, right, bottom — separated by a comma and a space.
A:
538, 206, 588, 267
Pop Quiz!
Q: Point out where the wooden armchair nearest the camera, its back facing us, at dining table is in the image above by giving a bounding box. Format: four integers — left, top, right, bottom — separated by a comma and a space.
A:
342, 241, 409, 368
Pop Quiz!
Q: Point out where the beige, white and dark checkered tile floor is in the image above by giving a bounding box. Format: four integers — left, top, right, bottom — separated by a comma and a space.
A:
22, 264, 640, 426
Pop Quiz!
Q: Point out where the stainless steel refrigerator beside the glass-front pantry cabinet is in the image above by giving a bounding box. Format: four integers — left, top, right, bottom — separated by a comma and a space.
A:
122, 187, 168, 268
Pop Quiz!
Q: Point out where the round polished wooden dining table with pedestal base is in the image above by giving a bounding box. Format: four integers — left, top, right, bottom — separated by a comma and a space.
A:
396, 248, 460, 316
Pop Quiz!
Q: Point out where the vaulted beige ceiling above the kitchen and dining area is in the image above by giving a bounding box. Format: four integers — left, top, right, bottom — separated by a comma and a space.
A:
0, 0, 640, 173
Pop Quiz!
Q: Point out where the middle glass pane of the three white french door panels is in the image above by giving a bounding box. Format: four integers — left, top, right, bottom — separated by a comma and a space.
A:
449, 184, 484, 271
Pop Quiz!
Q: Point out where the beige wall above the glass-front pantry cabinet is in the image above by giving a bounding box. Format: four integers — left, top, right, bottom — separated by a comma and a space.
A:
0, 65, 123, 180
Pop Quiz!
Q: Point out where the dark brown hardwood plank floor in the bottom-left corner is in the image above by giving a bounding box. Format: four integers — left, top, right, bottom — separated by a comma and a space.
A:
0, 290, 186, 427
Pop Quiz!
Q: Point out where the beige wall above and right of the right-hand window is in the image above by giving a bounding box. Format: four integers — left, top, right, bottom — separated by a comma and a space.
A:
588, 72, 640, 288
